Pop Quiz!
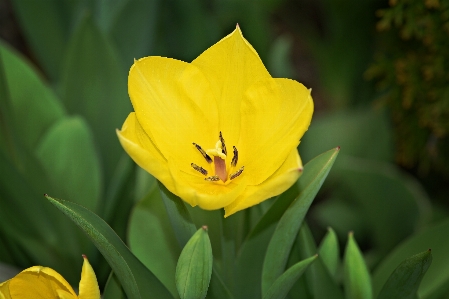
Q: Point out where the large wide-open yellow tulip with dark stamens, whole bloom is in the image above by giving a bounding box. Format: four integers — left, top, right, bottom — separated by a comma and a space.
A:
117, 26, 313, 216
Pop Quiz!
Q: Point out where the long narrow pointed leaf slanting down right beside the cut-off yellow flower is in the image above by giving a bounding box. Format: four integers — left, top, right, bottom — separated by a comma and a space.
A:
47, 196, 173, 299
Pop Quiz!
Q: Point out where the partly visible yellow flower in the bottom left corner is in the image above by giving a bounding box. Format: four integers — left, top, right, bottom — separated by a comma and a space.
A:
0, 256, 100, 299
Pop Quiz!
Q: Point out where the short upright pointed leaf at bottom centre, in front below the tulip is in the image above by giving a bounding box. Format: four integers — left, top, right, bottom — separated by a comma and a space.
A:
175, 226, 213, 299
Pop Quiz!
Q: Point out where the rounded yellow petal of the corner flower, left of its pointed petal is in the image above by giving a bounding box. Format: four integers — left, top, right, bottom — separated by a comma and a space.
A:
9, 266, 77, 299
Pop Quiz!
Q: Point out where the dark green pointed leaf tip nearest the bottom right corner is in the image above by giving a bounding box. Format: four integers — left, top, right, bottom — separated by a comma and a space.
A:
377, 249, 432, 299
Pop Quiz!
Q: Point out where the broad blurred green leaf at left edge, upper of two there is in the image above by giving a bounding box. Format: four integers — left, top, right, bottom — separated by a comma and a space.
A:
0, 42, 65, 150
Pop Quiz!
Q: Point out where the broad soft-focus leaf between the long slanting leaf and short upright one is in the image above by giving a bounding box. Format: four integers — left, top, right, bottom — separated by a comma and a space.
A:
128, 180, 181, 297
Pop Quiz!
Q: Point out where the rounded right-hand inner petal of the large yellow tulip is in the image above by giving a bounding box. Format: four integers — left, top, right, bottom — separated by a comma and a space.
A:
237, 79, 313, 185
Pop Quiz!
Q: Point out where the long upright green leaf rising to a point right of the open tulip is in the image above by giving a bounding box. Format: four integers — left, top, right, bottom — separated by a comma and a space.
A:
262, 148, 339, 293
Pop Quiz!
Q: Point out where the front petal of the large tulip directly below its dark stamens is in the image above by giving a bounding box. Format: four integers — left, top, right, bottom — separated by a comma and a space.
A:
167, 161, 246, 210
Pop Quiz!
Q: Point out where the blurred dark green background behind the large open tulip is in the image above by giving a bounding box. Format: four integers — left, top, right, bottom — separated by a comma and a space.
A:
0, 0, 449, 294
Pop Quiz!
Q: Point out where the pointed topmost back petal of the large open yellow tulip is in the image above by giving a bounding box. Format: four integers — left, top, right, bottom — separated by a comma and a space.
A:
192, 26, 271, 145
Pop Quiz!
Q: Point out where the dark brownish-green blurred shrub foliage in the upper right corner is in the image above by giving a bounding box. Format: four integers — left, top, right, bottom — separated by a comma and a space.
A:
366, 0, 449, 177
